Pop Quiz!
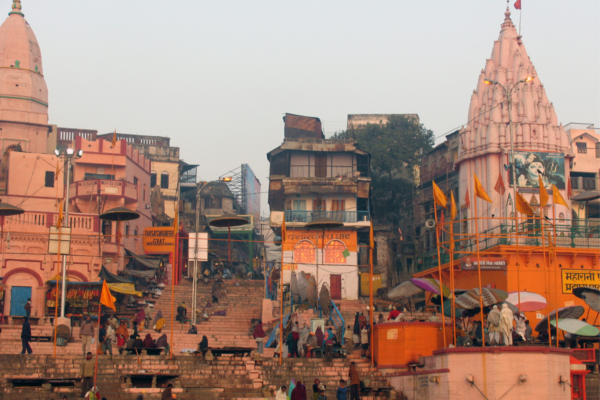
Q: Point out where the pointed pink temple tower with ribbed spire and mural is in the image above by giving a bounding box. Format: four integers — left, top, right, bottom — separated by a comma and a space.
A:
456, 9, 571, 231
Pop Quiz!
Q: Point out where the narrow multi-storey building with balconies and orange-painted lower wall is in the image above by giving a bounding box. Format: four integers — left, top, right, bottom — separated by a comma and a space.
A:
267, 114, 371, 299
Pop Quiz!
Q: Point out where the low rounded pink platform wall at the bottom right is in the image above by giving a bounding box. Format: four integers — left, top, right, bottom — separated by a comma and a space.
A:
387, 347, 571, 400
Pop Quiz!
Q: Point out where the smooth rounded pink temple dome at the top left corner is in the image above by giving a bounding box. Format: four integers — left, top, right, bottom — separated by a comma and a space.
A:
0, 0, 48, 124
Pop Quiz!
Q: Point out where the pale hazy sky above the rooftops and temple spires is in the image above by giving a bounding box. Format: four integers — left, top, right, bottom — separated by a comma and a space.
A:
21, 0, 600, 219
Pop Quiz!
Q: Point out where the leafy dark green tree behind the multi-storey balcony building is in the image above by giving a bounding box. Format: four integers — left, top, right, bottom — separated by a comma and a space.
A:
332, 115, 434, 225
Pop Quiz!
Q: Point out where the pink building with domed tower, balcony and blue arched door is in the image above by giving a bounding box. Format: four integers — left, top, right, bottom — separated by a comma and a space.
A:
0, 0, 152, 317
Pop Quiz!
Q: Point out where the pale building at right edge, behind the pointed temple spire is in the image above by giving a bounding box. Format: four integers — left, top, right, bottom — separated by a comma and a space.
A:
559, 123, 600, 225
